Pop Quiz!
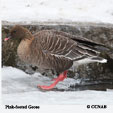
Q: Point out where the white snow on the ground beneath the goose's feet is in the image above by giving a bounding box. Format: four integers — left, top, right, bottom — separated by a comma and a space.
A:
2, 67, 113, 105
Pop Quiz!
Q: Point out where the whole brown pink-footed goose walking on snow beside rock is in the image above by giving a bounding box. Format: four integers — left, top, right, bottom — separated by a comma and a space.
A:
5, 25, 107, 90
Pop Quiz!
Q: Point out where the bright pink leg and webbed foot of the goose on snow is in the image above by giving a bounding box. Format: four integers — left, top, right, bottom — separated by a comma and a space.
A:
38, 71, 67, 90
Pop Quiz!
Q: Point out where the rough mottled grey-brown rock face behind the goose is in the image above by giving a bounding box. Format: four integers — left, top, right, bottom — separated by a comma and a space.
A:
2, 23, 113, 80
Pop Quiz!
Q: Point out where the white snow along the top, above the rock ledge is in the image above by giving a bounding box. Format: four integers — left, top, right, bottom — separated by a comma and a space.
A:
0, 0, 113, 24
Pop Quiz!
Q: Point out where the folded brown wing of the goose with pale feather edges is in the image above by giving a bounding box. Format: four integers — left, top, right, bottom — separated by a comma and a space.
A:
34, 30, 98, 60
